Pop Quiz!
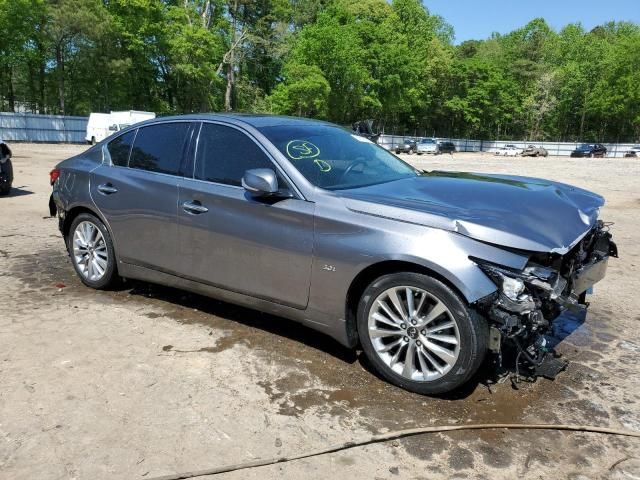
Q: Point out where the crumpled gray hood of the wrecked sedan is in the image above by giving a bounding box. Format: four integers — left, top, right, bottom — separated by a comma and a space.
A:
340, 172, 604, 254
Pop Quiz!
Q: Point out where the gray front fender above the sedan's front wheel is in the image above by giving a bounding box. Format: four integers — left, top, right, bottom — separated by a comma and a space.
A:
309, 206, 528, 330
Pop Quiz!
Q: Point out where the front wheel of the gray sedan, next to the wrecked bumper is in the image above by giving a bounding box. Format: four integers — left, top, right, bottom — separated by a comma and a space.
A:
357, 273, 488, 395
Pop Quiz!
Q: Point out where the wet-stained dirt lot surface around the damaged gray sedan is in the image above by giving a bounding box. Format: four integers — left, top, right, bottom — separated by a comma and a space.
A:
0, 144, 640, 480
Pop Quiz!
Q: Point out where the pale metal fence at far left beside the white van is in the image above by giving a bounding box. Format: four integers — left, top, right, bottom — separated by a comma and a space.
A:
0, 112, 89, 143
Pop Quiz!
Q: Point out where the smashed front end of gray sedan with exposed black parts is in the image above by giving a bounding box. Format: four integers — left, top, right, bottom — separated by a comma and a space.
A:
476, 221, 618, 378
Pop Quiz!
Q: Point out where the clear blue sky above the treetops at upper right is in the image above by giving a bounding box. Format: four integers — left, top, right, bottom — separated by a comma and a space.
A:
423, 0, 640, 43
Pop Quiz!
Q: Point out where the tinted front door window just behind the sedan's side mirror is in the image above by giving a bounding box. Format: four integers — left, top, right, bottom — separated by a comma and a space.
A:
195, 123, 274, 186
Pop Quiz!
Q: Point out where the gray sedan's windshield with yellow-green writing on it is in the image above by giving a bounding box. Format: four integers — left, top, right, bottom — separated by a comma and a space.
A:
258, 125, 418, 190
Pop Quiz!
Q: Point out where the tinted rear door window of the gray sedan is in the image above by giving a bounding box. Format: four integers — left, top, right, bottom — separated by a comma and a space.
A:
129, 122, 190, 175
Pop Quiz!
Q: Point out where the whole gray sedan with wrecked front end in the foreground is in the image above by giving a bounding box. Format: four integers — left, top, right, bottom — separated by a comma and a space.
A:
51, 115, 616, 394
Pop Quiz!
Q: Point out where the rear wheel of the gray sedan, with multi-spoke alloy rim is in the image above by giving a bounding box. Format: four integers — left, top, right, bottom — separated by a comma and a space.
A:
66, 213, 118, 290
